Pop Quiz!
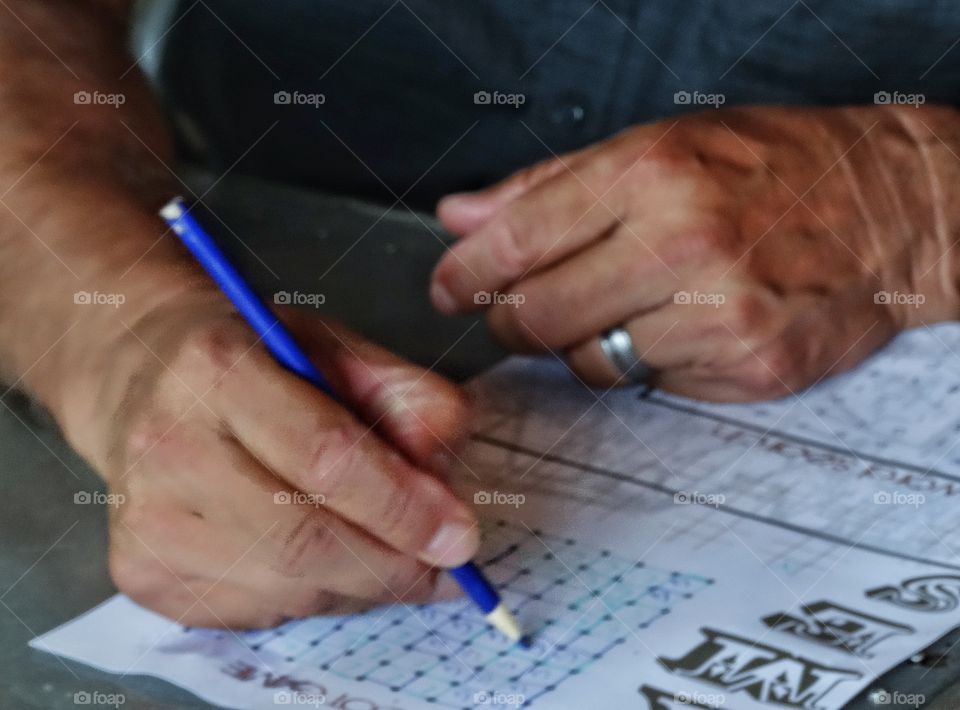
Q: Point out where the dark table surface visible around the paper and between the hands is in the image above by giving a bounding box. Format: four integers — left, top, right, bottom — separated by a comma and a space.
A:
0, 176, 960, 710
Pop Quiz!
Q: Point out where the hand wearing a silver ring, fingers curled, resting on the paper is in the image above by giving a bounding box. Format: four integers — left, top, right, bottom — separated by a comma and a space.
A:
431, 106, 960, 400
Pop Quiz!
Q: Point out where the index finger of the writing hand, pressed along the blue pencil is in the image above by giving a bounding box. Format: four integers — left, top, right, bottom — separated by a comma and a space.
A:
208, 349, 479, 566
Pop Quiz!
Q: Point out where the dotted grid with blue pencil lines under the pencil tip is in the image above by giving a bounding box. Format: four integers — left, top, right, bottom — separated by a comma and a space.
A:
225, 521, 713, 710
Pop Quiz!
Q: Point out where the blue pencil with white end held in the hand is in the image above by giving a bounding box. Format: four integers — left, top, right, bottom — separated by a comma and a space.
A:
160, 197, 522, 641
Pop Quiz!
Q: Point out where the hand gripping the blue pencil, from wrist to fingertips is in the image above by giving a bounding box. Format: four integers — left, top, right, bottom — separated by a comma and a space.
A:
67, 294, 478, 627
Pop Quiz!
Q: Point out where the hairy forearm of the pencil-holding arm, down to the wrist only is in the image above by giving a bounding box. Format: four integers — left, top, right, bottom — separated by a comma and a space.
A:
0, 0, 199, 450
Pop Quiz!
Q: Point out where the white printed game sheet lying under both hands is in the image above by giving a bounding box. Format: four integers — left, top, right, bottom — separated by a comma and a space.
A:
32, 325, 960, 710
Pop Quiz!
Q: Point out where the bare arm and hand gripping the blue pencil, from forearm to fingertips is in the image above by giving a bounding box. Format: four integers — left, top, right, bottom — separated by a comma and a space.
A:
0, 0, 478, 628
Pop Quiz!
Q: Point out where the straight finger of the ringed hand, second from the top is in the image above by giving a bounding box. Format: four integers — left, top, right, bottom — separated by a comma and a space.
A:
430, 165, 627, 313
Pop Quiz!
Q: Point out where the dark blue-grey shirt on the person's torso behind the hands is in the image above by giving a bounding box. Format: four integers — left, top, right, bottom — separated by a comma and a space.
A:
162, 0, 960, 207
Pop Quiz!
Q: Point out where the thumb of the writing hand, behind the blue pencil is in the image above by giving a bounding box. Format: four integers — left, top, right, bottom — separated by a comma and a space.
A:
290, 313, 470, 473
